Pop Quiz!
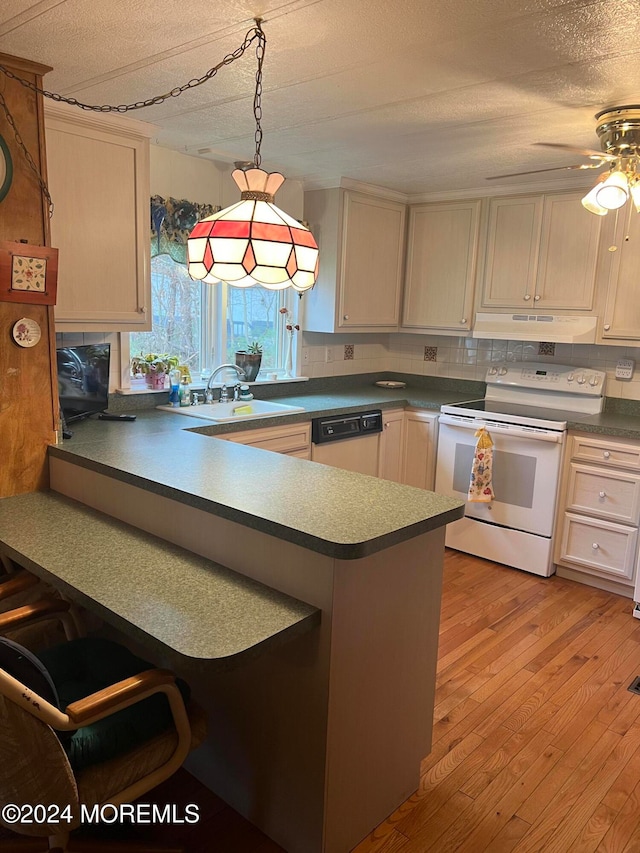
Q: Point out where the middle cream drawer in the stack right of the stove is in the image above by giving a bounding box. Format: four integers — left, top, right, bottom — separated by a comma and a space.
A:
567, 462, 640, 525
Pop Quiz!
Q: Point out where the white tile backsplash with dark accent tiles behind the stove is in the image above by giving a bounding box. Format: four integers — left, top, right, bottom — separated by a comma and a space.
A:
301, 332, 640, 400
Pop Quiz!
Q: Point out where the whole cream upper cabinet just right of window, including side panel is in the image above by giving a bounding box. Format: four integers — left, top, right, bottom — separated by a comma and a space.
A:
303, 188, 406, 332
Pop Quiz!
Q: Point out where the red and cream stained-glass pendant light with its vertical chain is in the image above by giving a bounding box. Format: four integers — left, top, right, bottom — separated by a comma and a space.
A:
187, 19, 318, 292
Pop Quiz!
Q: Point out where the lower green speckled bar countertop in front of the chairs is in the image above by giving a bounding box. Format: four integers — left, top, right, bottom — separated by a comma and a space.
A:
0, 492, 320, 668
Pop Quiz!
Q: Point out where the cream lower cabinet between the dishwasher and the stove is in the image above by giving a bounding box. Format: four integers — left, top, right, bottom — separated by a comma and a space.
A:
378, 409, 438, 489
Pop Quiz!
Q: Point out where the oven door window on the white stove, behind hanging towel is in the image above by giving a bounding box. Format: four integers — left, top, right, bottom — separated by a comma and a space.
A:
453, 444, 537, 509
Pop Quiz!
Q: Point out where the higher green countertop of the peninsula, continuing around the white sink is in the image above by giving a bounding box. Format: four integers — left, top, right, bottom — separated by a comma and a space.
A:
49, 387, 469, 559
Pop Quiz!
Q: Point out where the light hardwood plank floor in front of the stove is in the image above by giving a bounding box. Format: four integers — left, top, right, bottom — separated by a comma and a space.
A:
354, 551, 640, 853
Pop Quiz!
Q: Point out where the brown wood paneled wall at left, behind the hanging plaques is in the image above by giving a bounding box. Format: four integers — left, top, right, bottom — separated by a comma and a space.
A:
0, 54, 58, 497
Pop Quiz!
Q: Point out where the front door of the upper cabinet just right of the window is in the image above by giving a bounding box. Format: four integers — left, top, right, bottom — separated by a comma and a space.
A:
340, 192, 405, 329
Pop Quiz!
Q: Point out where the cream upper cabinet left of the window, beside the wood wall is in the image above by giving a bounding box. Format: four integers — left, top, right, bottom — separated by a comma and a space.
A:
45, 98, 152, 332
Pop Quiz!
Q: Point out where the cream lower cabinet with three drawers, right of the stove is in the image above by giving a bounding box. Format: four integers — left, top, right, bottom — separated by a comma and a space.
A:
556, 434, 640, 596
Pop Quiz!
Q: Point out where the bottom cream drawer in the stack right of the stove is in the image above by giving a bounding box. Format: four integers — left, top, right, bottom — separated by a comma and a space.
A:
560, 512, 638, 581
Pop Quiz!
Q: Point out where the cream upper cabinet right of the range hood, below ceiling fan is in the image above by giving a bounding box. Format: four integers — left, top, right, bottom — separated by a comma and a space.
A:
602, 204, 640, 340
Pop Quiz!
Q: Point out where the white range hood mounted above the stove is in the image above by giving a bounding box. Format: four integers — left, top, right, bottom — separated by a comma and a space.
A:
472, 314, 598, 344
